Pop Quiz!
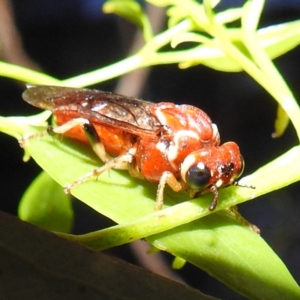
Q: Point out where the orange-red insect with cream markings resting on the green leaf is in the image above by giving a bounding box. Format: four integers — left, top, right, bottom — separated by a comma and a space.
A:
21, 86, 244, 211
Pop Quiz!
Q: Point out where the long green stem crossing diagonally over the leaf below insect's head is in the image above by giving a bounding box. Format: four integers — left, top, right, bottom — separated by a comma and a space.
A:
58, 146, 300, 250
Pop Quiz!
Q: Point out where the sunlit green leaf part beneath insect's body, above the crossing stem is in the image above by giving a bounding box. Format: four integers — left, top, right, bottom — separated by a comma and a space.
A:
22, 136, 155, 222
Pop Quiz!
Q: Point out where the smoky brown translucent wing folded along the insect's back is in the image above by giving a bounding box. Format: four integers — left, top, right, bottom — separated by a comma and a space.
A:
22, 85, 161, 135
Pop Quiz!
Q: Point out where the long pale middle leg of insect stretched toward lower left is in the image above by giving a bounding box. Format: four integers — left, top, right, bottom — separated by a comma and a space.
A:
64, 152, 134, 194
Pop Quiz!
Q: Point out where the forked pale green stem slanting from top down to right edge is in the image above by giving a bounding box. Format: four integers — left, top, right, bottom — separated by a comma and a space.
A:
178, 0, 300, 139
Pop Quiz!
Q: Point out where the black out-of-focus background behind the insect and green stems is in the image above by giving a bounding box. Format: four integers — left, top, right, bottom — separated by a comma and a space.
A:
0, 0, 300, 299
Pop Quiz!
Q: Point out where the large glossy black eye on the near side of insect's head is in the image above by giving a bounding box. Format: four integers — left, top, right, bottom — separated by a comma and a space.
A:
185, 163, 211, 190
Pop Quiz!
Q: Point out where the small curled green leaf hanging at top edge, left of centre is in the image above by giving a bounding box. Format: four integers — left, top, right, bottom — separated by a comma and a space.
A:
102, 0, 153, 41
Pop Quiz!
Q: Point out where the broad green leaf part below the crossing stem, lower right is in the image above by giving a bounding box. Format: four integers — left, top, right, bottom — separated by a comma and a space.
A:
147, 212, 300, 300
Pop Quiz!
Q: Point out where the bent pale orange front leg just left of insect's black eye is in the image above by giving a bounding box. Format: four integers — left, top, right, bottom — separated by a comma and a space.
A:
154, 171, 182, 211
